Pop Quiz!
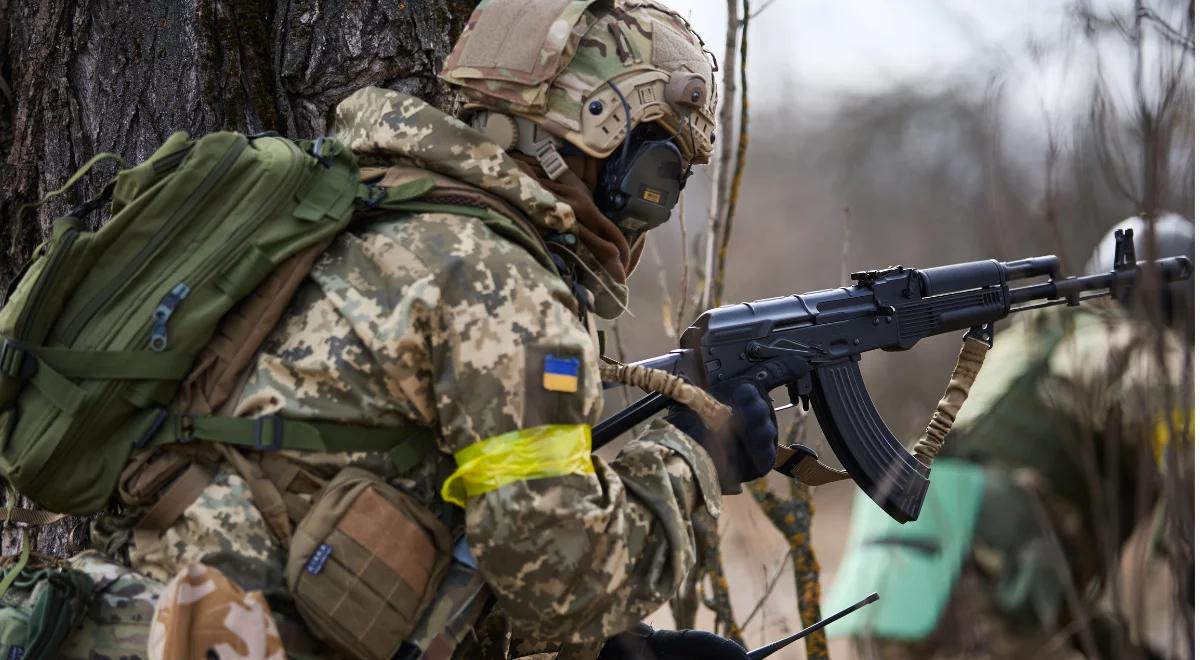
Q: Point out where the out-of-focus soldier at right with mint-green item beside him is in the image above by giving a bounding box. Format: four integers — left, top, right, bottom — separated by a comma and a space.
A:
835, 214, 1194, 658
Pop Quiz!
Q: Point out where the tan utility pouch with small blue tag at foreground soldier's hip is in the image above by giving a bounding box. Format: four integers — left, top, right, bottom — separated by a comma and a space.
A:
287, 468, 450, 660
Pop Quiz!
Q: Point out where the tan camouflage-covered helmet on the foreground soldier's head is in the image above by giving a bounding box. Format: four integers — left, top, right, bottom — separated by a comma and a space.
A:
442, 0, 716, 163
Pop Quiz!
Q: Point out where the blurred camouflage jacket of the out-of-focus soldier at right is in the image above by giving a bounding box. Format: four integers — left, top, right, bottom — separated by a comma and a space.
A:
942, 302, 1194, 625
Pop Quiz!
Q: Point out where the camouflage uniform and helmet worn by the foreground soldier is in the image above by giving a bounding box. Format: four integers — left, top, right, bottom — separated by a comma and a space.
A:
58, 0, 720, 658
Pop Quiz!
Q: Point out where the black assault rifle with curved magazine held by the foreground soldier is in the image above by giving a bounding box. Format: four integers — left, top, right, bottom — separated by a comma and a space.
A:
593, 230, 1192, 522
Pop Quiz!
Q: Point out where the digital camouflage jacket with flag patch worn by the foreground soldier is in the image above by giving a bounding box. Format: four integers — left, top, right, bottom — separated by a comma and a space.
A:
123, 89, 720, 657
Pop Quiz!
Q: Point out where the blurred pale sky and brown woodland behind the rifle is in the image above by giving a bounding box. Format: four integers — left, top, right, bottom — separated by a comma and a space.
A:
595, 0, 1195, 658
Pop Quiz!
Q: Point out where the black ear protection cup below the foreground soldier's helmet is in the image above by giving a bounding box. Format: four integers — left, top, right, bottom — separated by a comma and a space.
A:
595, 124, 691, 242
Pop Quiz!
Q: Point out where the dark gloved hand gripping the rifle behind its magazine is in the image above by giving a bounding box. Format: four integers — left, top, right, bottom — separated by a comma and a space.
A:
666, 380, 779, 494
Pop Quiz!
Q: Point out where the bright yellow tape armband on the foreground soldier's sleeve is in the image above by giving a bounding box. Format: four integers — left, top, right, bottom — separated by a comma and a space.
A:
442, 424, 595, 506
